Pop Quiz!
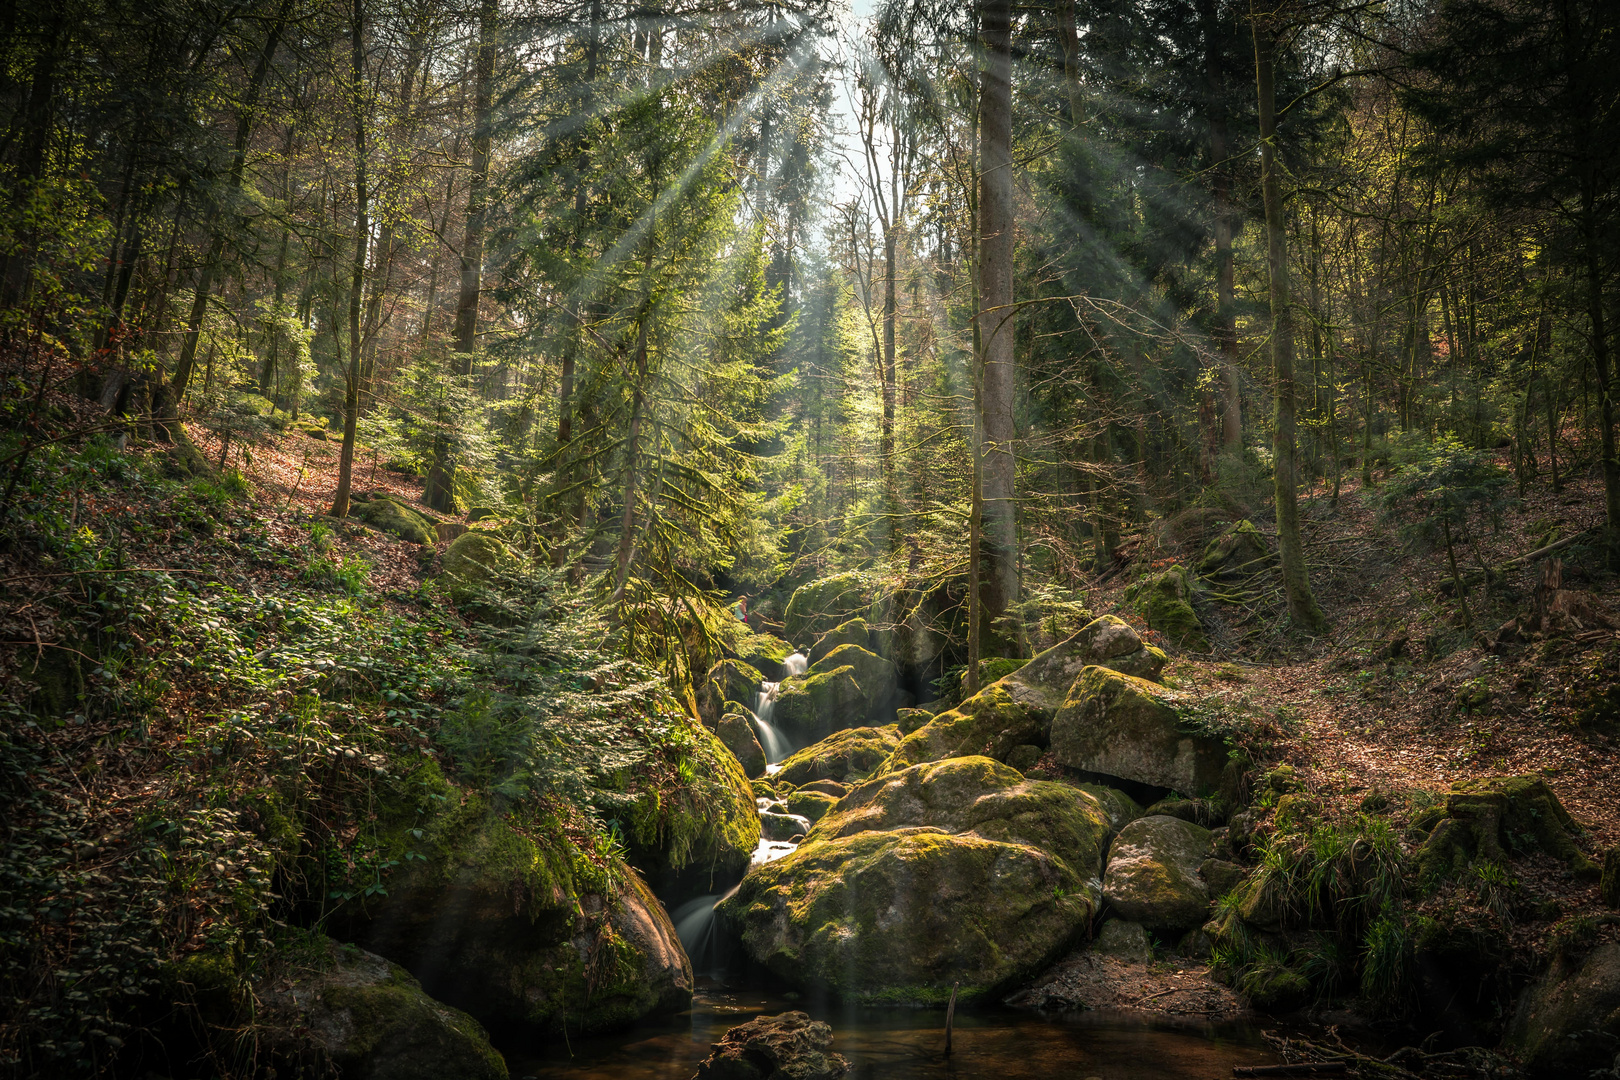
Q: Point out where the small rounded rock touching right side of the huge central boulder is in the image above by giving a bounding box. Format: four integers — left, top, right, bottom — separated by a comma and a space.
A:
1103, 816, 1210, 931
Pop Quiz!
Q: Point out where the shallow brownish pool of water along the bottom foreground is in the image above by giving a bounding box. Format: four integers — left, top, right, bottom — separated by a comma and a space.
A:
507, 986, 1280, 1080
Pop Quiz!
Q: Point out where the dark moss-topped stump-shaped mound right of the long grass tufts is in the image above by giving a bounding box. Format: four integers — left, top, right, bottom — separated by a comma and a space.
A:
1418, 776, 1601, 881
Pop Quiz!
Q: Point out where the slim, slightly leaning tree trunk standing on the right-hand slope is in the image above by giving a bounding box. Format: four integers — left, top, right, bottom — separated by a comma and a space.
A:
1251, 8, 1327, 630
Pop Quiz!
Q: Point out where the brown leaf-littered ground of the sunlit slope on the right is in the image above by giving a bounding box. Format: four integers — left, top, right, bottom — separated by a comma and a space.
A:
1094, 473, 1620, 1010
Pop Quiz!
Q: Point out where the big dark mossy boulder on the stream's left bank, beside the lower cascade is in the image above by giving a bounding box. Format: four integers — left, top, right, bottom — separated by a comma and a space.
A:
329, 777, 696, 1031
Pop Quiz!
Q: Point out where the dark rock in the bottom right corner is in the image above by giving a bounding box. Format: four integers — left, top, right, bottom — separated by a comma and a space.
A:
1503, 942, 1620, 1077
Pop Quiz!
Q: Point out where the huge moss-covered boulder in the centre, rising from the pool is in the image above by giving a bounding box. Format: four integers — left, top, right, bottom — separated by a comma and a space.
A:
721, 758, 1108, 1004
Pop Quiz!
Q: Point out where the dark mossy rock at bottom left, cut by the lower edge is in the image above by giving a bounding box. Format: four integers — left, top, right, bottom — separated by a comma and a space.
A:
256, 936, 507, 1080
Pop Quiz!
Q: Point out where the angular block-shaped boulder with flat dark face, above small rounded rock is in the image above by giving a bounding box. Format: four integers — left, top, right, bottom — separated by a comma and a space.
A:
1051, 667, 1226, 795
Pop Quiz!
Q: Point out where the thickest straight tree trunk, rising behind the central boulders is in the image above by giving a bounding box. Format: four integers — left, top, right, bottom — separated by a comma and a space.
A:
978, 0, 1022, 653
